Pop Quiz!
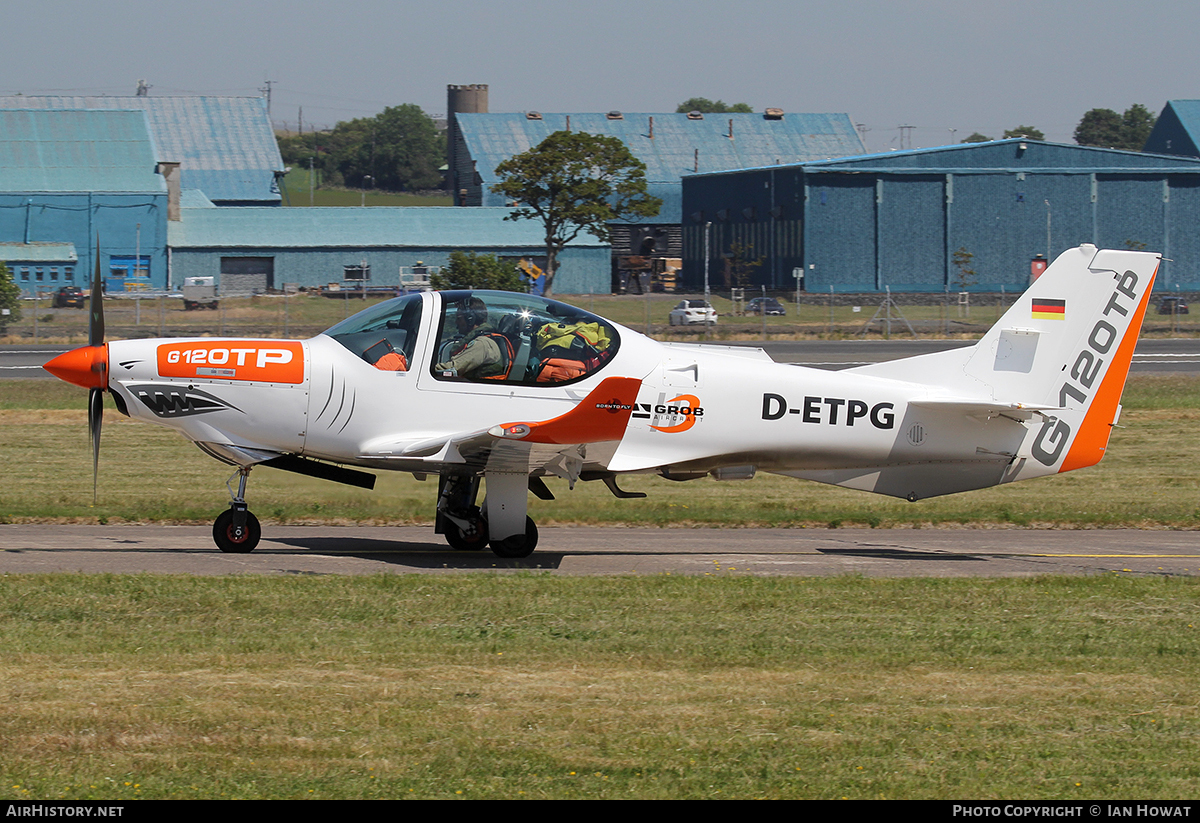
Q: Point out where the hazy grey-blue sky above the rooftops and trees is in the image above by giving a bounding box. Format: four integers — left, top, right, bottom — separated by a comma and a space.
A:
9, 0, 1200, 151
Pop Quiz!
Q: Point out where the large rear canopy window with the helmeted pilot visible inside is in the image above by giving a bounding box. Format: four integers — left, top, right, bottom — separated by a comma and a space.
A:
432, 290, 620, 385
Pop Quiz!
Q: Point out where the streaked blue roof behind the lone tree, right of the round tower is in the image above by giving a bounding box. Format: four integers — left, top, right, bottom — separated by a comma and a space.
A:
455, 113, 865, 185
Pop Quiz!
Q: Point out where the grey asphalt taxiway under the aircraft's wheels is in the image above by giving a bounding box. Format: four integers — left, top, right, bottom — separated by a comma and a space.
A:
0, 524, 1200, 577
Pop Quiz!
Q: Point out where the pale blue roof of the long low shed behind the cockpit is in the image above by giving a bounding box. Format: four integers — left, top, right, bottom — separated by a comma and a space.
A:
168, 206, 607, 248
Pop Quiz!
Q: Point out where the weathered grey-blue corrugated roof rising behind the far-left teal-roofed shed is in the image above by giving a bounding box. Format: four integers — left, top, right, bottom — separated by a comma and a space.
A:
0, 95, 283, 204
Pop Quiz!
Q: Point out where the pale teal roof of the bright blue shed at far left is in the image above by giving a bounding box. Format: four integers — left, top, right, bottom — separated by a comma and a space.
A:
0, 109, 167, 192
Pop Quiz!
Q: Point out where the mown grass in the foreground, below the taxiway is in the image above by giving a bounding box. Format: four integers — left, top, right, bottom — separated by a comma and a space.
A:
0, 573, 1200, 800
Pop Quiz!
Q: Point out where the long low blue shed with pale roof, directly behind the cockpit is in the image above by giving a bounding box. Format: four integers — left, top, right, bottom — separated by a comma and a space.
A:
168, 205, 610, 294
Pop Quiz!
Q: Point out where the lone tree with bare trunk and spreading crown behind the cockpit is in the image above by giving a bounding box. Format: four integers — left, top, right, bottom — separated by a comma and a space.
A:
492, 132, 662, 301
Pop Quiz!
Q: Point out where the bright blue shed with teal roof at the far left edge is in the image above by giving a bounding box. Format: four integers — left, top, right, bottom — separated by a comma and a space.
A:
0, 109, 168, 294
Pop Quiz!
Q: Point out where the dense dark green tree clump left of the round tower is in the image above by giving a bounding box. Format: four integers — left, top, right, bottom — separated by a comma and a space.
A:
278, 103, 445, 192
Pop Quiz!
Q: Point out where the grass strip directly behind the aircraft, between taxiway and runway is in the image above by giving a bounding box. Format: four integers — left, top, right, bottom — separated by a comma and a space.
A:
0, 376, 1200, 529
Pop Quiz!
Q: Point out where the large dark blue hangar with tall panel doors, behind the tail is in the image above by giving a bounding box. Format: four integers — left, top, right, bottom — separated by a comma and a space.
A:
683, 138, 1200, 293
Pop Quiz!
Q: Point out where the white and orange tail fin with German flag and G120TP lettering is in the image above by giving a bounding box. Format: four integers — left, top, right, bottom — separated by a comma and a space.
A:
856, 245, 1162, 480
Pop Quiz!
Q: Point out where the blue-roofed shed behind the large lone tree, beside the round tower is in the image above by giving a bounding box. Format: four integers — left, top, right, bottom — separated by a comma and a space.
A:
450, 109, 865, 266
